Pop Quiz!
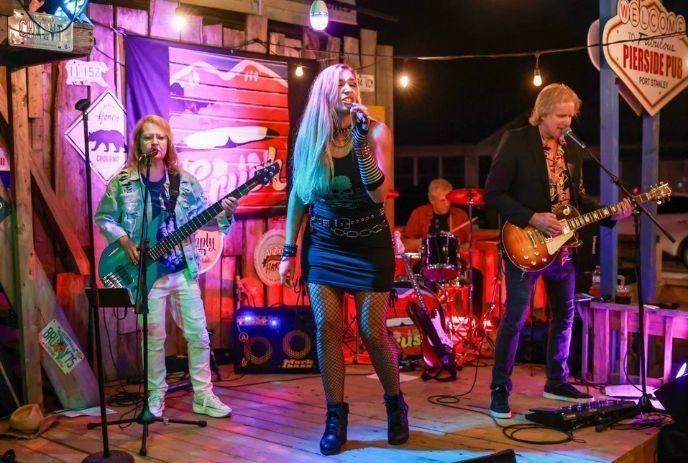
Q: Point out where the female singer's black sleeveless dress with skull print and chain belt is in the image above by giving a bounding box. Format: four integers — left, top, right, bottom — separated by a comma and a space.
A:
301, 151, 394, 292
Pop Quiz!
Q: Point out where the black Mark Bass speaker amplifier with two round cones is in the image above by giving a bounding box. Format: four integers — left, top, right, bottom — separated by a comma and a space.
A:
232, 306, 319, 373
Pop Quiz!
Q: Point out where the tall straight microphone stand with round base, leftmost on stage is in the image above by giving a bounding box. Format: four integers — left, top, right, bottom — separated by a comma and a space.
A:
75, 98, 134, 463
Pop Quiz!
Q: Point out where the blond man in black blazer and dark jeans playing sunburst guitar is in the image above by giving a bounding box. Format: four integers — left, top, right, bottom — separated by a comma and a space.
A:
485, 84, 631, 418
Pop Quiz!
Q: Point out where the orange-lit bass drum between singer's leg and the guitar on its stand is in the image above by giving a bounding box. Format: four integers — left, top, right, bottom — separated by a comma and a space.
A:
387, 275, 440, 359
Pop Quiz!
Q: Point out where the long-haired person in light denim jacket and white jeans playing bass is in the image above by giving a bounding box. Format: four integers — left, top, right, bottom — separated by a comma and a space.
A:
95, 115, 237, 418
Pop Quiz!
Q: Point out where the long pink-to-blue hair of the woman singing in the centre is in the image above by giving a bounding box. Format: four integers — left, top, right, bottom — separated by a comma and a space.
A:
292, 63, 360, 204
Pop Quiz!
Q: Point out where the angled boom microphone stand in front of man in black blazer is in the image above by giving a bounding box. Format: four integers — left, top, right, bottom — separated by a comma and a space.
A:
563, 129, 676, 420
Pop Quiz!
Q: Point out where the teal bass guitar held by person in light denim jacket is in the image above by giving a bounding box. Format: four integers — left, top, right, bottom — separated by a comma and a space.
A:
98, 162, 280, 302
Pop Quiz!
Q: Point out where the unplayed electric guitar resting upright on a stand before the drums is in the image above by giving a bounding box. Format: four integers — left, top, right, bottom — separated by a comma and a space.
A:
402, 253, 456, 381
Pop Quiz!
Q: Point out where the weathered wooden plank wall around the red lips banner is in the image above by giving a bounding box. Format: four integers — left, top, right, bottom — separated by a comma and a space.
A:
0, 0, 393, 379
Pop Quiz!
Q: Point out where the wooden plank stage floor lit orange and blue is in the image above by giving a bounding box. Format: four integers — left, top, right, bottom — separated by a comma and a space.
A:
0, 361, 657, 463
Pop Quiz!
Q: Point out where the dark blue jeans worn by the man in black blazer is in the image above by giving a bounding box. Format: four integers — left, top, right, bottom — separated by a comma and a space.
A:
490, 259, 576, 390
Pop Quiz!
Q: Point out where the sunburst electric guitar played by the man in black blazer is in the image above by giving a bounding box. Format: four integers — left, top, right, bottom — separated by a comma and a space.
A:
502, 183, 671, 272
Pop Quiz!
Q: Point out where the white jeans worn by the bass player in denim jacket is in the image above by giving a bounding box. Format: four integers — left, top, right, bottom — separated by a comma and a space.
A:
138, 270, 212, 394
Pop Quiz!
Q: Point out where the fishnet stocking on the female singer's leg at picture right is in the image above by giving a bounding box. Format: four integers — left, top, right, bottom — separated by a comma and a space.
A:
354, 291, 399, 396
